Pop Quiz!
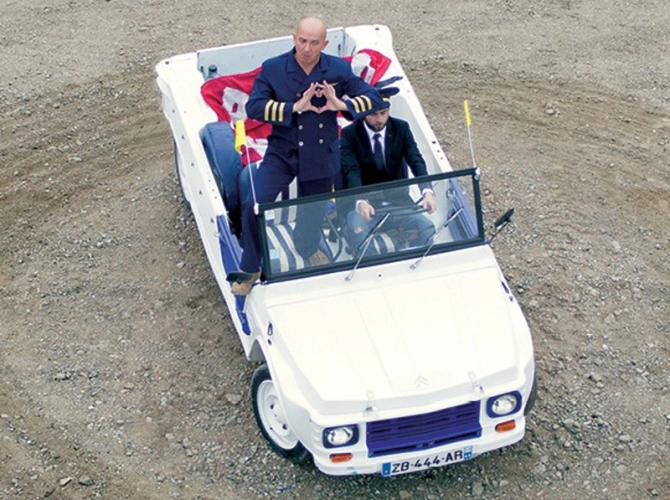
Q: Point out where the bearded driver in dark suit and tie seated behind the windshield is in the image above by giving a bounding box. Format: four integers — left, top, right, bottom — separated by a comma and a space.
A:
340, 87, 437, 255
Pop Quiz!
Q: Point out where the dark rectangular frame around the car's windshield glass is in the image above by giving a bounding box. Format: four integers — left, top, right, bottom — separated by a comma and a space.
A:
257, 168, 486, 283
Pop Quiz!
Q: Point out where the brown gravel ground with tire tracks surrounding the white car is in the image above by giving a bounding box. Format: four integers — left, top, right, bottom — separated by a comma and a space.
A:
0, 0, 670, 500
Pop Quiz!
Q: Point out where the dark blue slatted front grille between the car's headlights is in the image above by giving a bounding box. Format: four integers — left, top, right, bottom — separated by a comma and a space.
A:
366, 401, 482, 457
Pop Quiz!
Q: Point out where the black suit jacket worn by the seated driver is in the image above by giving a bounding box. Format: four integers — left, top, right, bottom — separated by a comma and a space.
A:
340, 117, 430, 202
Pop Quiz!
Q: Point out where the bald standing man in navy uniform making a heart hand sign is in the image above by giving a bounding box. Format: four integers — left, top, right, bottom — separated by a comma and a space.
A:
232, 17, 381, 295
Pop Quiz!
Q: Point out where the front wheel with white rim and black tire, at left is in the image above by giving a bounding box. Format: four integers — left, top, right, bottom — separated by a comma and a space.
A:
251, 364, 310, 464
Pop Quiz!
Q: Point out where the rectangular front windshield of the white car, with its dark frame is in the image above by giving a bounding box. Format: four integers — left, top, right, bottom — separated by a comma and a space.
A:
259, 169, 485, 282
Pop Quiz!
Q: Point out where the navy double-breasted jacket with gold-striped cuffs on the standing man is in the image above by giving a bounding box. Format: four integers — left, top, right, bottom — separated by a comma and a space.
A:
245, 49, 381, 181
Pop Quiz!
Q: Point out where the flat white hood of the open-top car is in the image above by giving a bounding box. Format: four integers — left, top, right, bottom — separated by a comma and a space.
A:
268, 265, 520, 414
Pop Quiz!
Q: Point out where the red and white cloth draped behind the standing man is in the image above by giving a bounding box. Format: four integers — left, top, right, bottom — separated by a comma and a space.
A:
200, 49, 391, 165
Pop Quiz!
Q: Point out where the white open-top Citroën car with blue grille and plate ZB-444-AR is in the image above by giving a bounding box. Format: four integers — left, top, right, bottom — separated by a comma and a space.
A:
156, 25, 535, 476
